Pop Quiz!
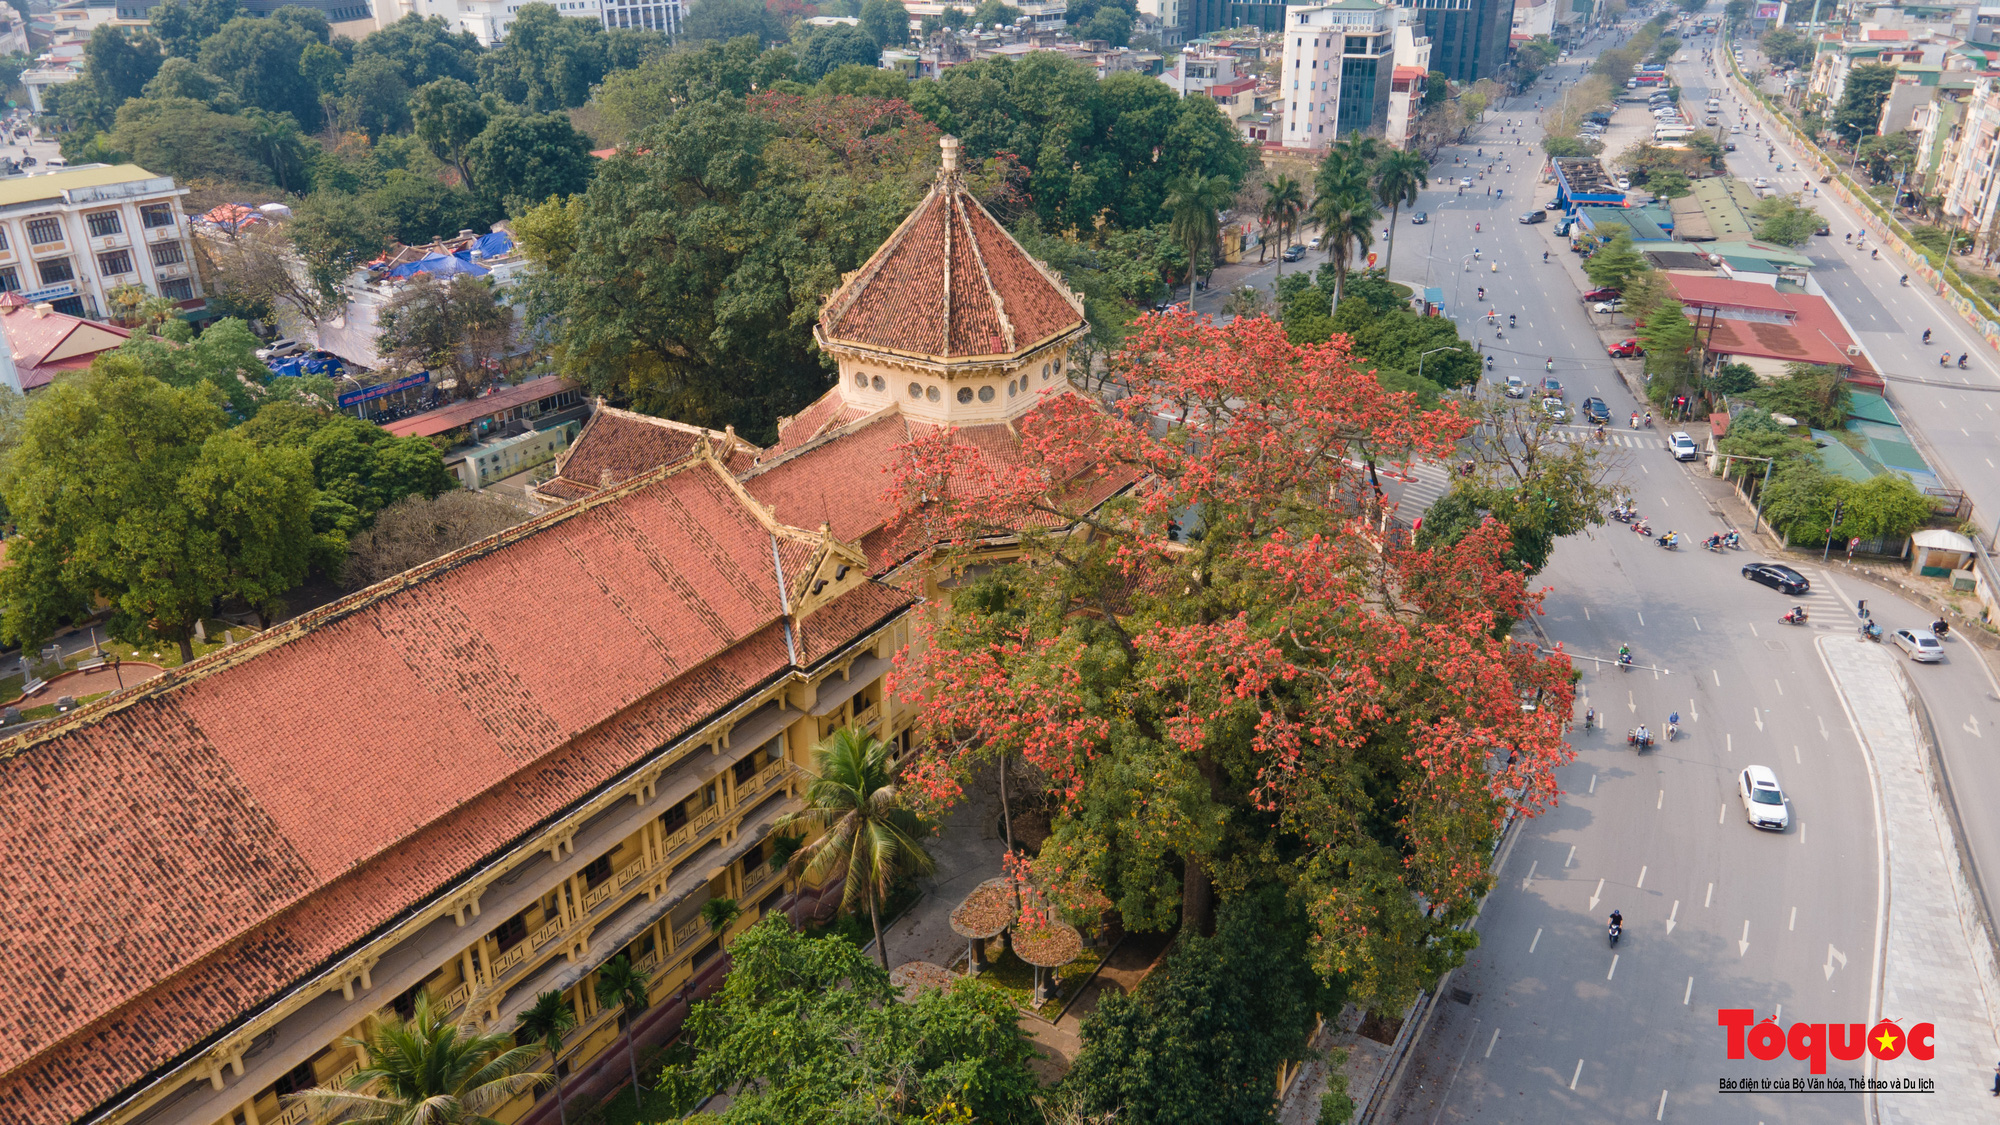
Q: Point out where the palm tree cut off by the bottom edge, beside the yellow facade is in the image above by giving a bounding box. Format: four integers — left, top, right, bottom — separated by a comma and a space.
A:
292, 993, 550, 1125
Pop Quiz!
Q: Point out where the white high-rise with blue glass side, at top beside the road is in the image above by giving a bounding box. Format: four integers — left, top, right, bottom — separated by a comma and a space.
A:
1278, 0, 1396, 148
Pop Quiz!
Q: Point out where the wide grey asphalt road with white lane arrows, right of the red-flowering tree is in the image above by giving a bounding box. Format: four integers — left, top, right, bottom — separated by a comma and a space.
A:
1388, 28, 2000, 1123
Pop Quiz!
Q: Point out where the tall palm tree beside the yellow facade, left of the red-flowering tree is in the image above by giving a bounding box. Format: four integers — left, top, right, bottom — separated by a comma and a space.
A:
772, 720, 940, 969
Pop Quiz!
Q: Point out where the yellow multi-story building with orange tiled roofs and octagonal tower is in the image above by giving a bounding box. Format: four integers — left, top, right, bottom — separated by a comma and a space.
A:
0, 138, 1130, 1125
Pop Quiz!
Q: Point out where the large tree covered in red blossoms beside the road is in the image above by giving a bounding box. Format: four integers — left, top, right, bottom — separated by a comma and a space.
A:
896, 316, 1572, 1007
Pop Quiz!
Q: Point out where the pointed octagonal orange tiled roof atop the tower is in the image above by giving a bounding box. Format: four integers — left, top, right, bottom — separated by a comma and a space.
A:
820, 160, 1084, 360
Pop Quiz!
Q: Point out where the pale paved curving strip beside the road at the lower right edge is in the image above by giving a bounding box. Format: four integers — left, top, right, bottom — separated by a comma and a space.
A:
1818, 624, 2000, 1125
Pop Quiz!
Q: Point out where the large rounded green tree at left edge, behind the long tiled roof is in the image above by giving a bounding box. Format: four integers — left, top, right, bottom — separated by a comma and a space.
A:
0, 354, 314, 661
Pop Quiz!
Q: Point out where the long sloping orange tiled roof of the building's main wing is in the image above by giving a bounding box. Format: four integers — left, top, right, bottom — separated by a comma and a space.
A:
0, 450, 910, 1125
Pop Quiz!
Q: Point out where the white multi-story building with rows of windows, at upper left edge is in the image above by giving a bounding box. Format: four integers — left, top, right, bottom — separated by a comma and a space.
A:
0, 164, 202, 320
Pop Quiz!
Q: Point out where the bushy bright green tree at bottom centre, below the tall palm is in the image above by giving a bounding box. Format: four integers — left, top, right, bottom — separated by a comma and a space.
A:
688, 915, 1040, 1125
